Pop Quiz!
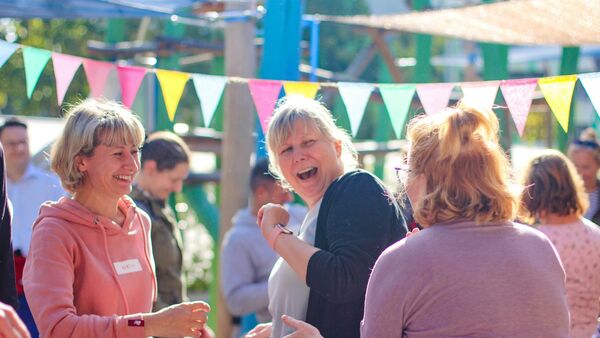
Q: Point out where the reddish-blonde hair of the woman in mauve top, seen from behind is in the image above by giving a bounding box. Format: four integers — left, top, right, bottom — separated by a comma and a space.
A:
407, 102, 517, 225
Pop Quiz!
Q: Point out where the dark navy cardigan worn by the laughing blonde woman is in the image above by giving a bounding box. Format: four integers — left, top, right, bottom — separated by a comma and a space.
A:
306, 170, 407, 338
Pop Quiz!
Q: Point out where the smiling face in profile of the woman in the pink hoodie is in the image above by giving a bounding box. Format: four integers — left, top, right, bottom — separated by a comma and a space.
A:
76, 143, 140, 200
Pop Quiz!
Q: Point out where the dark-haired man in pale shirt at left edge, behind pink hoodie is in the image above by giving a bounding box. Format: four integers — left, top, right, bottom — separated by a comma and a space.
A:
0, 118, 65, 338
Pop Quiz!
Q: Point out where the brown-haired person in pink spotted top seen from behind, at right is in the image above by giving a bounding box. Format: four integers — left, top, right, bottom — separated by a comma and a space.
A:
521, 150, 600, 338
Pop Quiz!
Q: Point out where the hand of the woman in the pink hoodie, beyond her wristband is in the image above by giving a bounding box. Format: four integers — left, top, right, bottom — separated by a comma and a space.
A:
144, 302, 210, 337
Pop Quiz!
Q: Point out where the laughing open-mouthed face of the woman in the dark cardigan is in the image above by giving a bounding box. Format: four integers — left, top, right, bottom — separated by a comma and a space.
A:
275, 120, 344, 207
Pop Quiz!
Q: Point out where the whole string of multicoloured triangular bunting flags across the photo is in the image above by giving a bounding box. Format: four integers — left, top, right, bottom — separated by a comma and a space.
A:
0, 40, 600, 138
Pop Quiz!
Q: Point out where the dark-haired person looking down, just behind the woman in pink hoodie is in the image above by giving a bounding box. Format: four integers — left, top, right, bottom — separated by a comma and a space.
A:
129, 131, 190, 311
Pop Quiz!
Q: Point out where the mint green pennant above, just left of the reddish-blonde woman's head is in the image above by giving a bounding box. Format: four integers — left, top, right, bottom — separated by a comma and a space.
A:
379, 84, 417, 138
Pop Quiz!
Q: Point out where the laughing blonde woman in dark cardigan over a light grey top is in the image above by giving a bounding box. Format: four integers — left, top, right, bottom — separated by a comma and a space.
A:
250, 96, 406, 338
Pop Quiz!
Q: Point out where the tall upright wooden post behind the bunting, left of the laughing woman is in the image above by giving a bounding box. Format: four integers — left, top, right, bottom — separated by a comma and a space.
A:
220, 1, 256, 338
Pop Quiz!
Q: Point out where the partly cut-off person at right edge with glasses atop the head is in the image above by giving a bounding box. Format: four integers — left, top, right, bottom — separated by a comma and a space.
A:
567, 128, 600, 224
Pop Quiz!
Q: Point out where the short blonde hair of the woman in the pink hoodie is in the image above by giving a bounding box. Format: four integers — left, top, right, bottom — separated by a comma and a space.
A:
50, 99, 144, 193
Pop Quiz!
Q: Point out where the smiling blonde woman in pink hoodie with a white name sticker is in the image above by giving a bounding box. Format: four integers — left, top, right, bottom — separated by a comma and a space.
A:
23, 100, 210, 337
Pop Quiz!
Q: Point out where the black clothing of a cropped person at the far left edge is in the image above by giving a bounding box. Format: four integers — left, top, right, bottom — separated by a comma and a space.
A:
0, 145, 17, 309
